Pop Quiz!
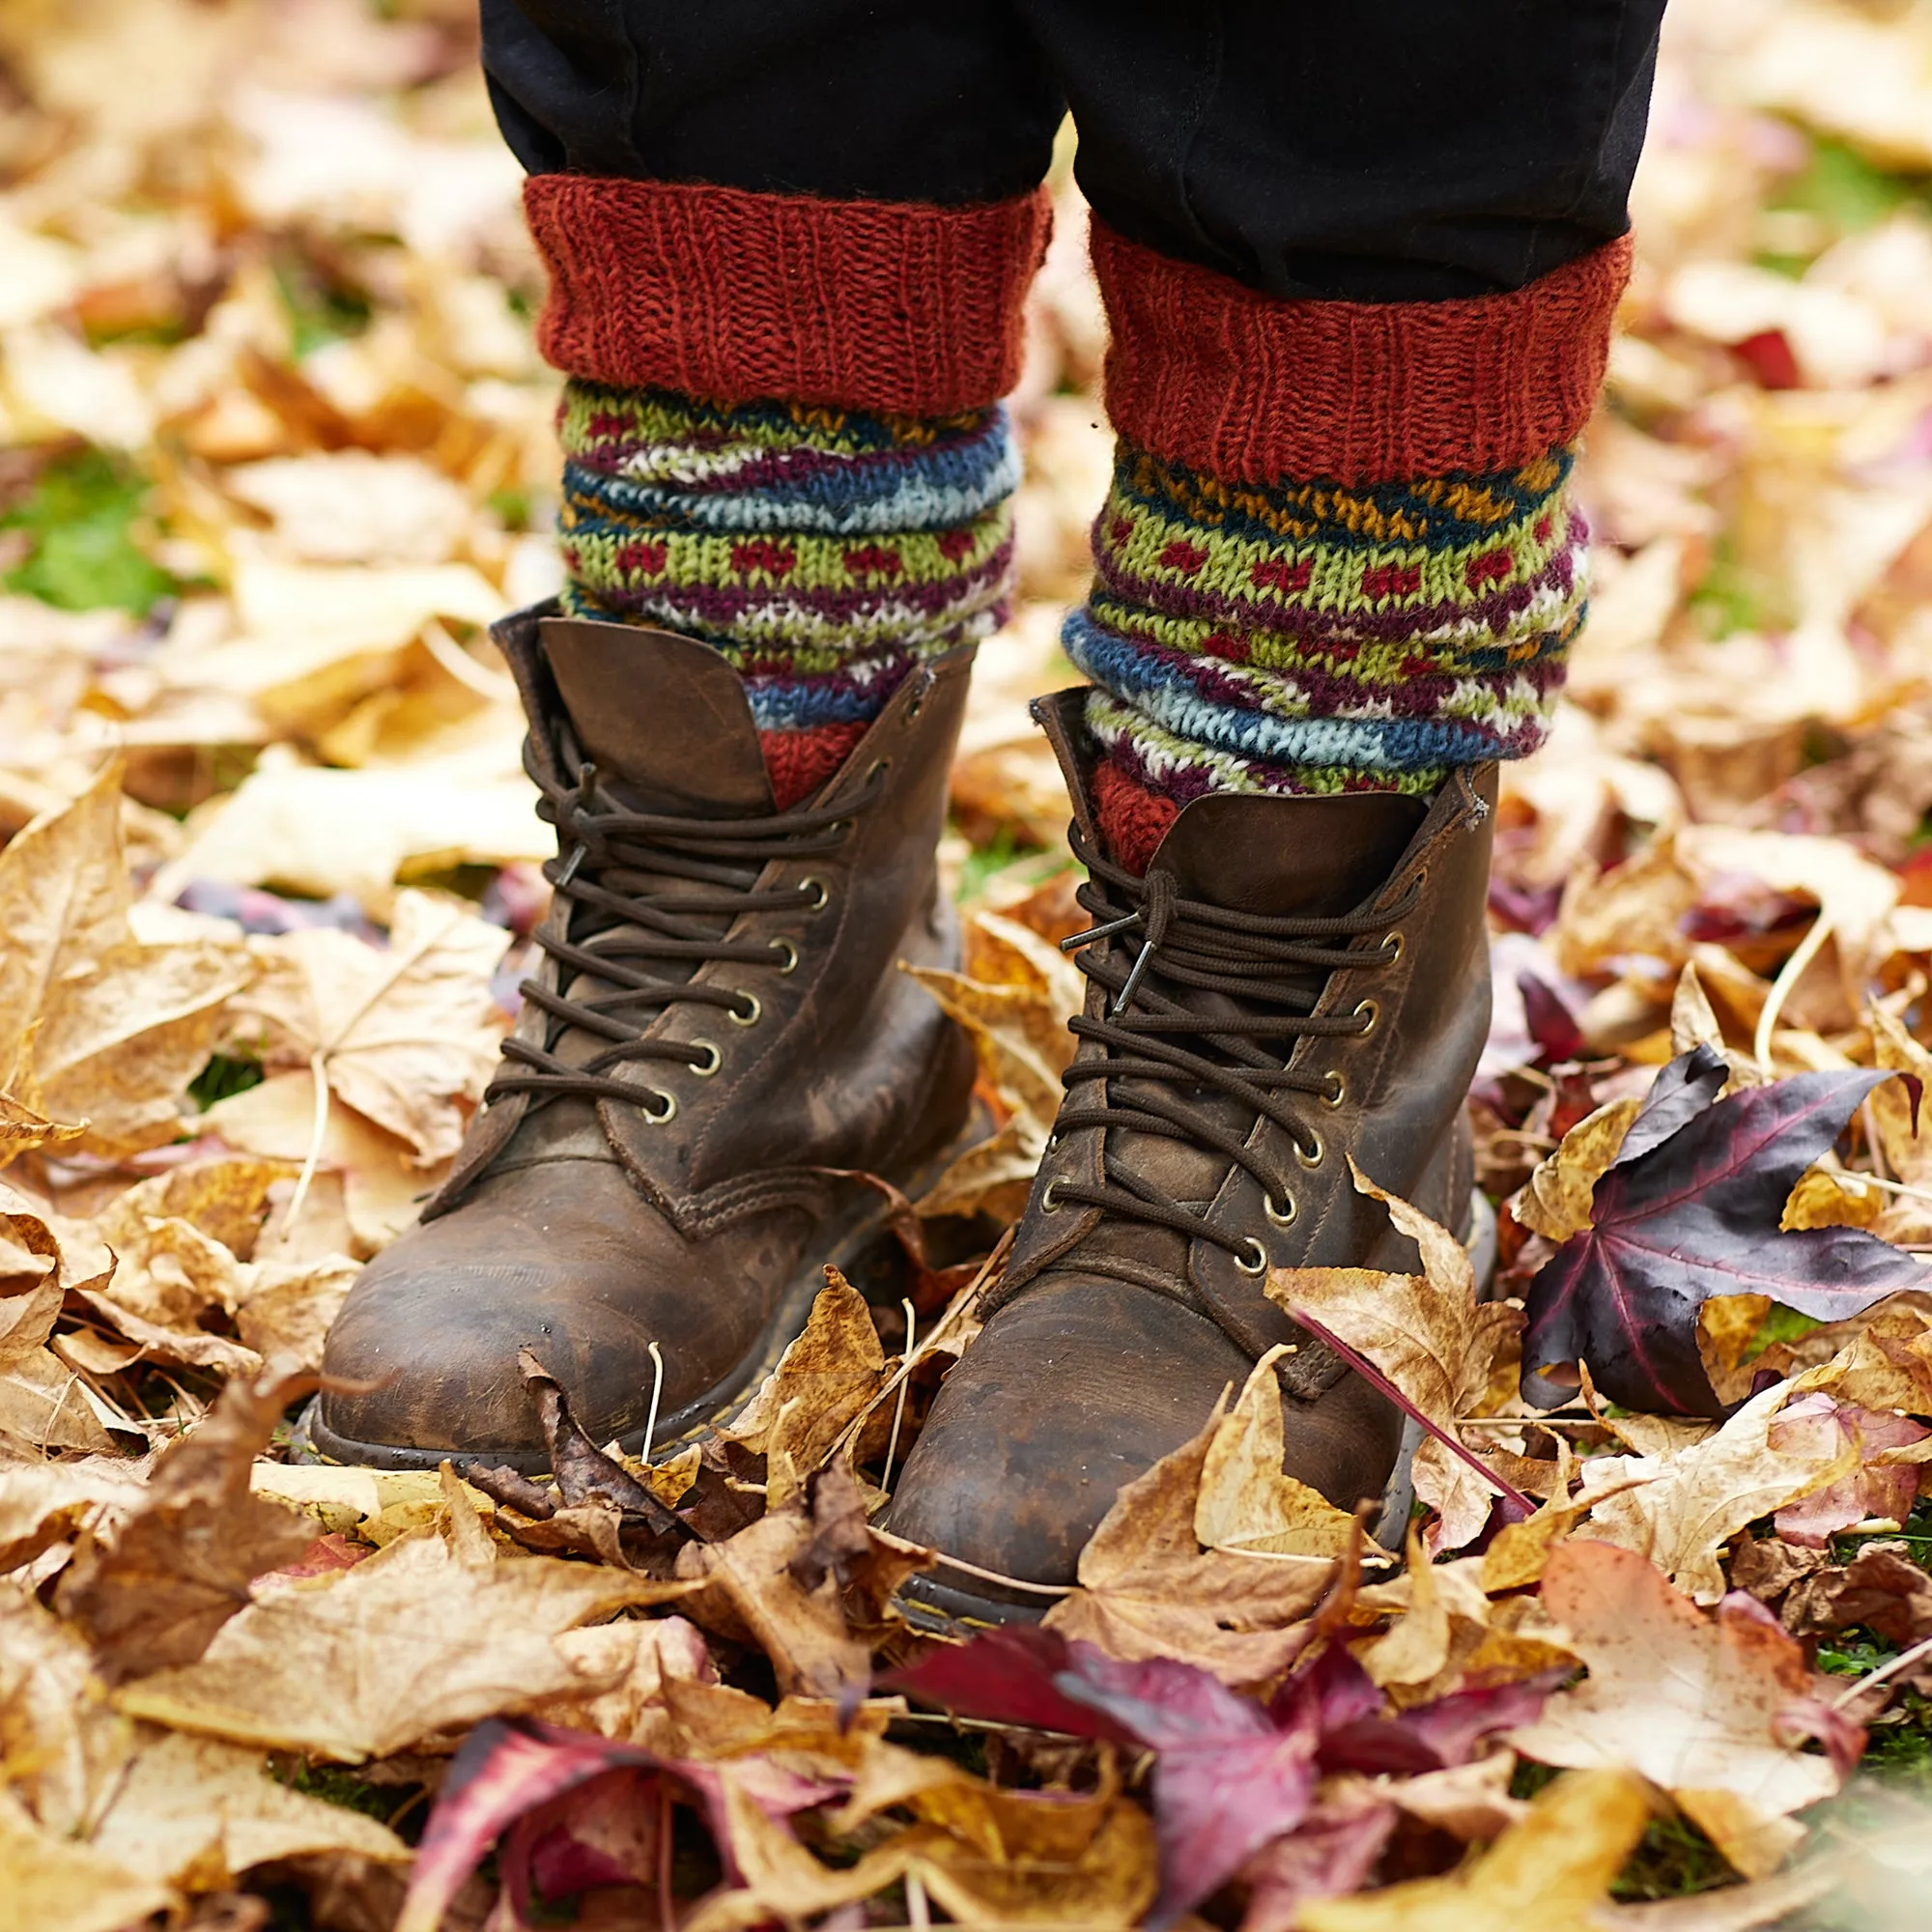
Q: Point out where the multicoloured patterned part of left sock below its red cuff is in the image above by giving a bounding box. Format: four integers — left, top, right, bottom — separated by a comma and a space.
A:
560, 381, 1020, 808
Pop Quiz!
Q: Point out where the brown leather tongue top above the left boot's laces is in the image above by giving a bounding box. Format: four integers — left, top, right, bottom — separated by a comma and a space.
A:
541, 616, 777, 819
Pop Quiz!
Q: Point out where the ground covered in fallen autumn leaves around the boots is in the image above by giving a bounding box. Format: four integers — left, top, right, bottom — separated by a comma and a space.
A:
0, 0, 1932, 1932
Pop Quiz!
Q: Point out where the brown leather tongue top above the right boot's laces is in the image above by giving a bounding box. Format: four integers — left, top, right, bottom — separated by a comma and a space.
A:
1148, 792, 1430, 918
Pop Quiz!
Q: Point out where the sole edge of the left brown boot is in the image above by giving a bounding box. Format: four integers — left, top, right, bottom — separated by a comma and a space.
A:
301, 1101, 991, 1476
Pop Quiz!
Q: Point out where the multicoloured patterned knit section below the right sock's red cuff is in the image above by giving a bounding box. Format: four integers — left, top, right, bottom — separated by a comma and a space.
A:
1063, 446, 1588, 802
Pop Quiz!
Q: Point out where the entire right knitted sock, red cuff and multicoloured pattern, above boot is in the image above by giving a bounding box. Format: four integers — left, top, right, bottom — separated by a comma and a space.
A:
1063, 224, 1625, 867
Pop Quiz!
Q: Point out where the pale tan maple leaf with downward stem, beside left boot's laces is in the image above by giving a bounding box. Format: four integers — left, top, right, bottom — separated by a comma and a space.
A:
234, 893, 510, 1165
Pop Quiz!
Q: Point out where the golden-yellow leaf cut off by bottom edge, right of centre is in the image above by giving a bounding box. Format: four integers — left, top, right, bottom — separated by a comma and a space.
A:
1296, 1772, 1650, 1932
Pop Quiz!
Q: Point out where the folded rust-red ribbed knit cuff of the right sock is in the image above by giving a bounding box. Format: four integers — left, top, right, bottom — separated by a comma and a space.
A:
1094, 218, 1631, 487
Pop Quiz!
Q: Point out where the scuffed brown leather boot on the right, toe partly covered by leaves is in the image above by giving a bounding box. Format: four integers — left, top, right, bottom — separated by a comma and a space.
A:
889, 692, 1495, 1621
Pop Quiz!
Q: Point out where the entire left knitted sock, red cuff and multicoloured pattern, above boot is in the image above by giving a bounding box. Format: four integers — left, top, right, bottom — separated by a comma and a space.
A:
524, 174, 1049, 806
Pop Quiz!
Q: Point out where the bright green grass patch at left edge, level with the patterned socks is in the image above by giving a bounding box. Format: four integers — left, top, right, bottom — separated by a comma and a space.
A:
0, 448, 176, 616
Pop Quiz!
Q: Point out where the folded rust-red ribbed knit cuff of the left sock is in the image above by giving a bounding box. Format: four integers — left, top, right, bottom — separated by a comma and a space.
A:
524, 174, 1051, 415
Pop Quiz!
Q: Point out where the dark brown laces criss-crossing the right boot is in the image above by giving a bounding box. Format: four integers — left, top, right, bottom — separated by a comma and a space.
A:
1041, 827, 1422, 1275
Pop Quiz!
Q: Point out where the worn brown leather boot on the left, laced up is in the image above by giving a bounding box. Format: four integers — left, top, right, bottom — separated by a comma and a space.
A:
311, 611, 974, 1470
